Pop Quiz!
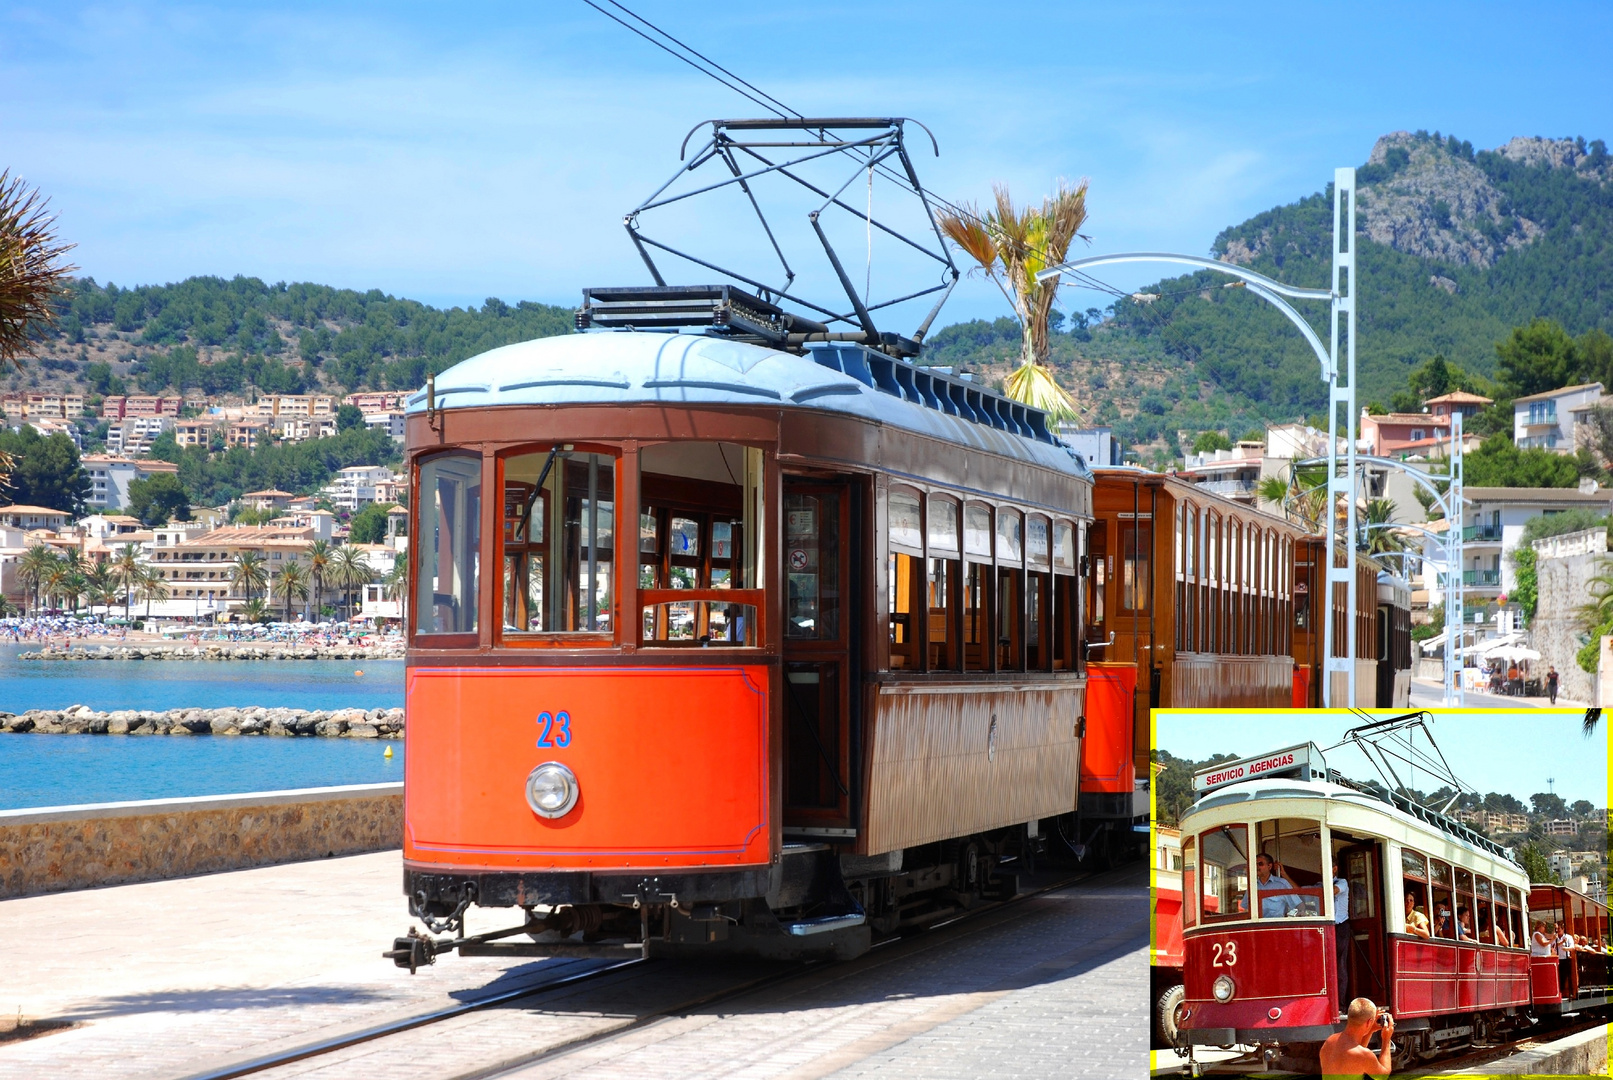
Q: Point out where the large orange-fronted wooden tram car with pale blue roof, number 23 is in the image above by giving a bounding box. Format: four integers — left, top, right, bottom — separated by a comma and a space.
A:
400, 332, 1147, 962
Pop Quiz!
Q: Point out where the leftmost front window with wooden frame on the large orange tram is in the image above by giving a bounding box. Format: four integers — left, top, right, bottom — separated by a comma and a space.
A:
410, 448, 484, 648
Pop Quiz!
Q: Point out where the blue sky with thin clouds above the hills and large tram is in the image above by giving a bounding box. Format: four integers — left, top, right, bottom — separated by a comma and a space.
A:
0, 0, 1613, 329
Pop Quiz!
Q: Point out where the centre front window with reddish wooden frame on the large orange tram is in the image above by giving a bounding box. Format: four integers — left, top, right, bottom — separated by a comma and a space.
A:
494, 442, 616, 648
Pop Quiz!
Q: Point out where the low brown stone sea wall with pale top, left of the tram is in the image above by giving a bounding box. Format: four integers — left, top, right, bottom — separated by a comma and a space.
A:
0, 783, 403, 898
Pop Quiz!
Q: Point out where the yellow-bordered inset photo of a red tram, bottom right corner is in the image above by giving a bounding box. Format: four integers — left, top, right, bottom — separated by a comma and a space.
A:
1152, 709, 1613, 1075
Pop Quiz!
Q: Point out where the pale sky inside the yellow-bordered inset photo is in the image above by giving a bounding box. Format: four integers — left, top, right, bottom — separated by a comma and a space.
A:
1155, 709, 1608, 808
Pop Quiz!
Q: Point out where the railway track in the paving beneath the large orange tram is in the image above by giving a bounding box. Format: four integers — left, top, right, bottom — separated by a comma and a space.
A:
173, 867, 1127, 1080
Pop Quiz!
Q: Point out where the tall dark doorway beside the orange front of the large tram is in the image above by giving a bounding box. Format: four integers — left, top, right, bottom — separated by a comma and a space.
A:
781, 477, 857, 838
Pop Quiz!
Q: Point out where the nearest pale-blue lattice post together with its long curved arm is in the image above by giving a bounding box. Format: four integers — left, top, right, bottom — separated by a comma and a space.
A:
1036, 168, 1361, 708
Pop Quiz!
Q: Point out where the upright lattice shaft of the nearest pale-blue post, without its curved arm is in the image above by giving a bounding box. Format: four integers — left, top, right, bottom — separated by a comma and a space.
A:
1321, 168, 1358, 709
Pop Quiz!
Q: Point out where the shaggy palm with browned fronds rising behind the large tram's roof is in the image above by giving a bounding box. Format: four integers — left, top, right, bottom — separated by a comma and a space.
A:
937, 181, 1087, 421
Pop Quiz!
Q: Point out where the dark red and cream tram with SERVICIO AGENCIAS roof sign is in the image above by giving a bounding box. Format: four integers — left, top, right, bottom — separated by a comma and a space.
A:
1176, 745, 1608, 1067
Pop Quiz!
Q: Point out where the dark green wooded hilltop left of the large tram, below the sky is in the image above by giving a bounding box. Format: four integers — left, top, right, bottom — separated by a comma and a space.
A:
58, 277, 573, 393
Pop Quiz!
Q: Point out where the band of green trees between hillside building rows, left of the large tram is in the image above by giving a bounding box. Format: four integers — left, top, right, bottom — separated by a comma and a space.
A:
179, 429, 398, 506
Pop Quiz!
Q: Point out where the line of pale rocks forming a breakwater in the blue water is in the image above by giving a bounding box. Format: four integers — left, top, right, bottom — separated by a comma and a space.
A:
0, 704, 403, 738
